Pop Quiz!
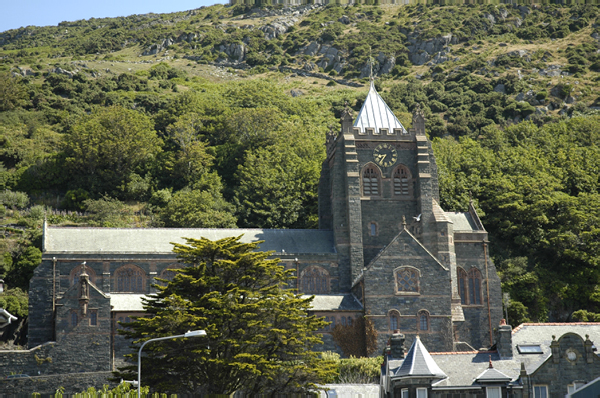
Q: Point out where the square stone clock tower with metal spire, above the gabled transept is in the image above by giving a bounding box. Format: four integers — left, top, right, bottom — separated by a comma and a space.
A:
319, 83, 439, 284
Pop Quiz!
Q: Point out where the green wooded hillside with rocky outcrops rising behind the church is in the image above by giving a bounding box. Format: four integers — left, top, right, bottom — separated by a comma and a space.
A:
0, 4, 600, 338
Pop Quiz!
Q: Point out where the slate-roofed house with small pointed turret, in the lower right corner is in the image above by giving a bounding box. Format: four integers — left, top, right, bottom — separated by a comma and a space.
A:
381, 323, 600, 398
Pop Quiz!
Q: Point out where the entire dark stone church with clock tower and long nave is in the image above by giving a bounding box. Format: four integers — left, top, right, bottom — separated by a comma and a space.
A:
22, 84, 502, 374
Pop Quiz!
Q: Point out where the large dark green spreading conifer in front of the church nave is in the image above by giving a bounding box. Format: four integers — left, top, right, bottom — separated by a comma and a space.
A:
119, 237, 334, 395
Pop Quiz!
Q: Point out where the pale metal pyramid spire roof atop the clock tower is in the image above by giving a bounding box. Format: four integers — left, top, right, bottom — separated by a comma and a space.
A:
354, 81, 406, 132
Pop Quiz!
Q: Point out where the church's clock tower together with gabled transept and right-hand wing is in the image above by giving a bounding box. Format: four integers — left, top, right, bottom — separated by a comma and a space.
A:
319, 82, 502, 351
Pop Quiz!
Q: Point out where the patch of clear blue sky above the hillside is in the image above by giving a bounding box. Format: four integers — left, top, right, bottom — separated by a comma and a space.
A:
0, 0, 228, 32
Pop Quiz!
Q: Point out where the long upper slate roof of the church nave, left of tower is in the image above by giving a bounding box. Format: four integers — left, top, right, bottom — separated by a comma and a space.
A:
43, 226, 335, 254
